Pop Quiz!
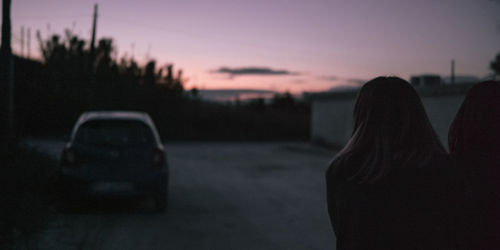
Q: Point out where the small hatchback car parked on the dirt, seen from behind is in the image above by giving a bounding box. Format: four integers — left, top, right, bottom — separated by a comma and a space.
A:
60, 111, 169, 211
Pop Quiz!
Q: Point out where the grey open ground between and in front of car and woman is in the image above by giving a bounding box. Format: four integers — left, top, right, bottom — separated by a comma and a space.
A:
24, 140, 335, 249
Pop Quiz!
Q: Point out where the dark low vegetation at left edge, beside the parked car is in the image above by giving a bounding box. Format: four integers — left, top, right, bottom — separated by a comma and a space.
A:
0, 139, 57, 249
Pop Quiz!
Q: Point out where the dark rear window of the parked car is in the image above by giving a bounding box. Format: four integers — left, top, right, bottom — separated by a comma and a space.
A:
75, 119, 154, 146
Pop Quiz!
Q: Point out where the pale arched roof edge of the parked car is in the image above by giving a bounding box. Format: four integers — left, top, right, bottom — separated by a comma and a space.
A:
71, 110, 160, 143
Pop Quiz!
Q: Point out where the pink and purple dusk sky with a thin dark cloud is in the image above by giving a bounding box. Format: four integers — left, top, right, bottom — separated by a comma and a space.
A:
6, 0, 500, 93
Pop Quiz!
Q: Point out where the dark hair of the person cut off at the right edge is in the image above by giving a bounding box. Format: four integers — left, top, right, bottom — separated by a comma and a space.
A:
448, 81, 500, 160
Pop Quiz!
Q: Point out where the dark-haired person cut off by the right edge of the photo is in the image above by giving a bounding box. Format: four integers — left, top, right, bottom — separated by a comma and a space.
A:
448, 81, 500, 249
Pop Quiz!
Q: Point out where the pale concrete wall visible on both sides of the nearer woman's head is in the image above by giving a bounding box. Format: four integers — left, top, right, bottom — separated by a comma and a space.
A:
311, 85, 470, 147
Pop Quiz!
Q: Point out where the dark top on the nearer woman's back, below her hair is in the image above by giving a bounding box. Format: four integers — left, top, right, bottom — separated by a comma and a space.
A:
326, 152, 463, 250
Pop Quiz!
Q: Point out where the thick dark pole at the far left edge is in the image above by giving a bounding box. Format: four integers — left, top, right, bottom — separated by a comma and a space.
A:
0, 0, 14, 135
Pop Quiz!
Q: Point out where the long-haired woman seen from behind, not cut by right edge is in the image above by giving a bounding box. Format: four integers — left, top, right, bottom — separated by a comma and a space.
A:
326, 77, 460, 250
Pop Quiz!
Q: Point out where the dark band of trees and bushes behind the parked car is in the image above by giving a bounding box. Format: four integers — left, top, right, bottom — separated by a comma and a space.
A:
15, 31, 310, 140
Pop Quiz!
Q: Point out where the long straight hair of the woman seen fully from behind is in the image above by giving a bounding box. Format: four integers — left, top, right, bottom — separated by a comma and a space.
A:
329, 77, 446, 183
